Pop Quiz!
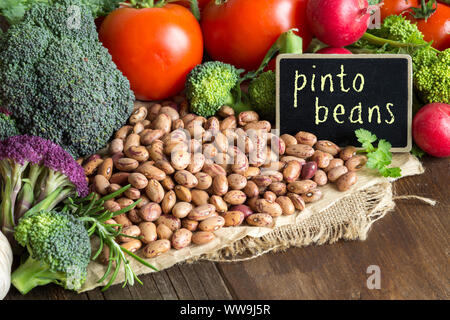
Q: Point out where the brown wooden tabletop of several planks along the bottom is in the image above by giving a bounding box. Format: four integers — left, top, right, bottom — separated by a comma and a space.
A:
7, 158, 450, 300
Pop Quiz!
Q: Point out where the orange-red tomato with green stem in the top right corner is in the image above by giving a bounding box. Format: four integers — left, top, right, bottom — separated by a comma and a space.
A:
408, 3, 450, 50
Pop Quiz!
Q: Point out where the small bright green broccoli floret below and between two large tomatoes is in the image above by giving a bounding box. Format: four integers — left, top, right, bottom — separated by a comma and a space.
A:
186, 61, 241, 117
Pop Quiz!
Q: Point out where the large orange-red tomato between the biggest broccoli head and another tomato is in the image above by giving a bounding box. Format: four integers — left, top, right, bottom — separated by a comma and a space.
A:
99, 4, 203, 100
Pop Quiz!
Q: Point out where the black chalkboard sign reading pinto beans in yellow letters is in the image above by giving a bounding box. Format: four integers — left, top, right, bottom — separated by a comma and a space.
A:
276, 54, 412, 152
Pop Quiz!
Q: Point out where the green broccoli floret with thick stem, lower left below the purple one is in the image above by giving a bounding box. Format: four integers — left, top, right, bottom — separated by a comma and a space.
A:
11, 211, 91, 294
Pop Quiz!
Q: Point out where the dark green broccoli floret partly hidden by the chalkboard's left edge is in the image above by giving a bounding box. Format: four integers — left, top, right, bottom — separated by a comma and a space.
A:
248, 71, 276, 121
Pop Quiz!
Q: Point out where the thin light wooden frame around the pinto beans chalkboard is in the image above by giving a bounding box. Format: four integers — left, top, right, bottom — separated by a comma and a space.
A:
275, 53, 413, 152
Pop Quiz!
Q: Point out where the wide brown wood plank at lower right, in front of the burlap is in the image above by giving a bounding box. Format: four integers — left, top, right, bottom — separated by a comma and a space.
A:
219, 159, 450, 299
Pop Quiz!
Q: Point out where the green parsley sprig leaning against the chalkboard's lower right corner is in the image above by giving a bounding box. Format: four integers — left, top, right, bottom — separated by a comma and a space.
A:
355, 129, 402, 178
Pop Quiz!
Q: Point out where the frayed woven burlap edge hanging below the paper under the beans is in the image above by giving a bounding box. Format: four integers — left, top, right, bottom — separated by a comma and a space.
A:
187, 182, 395, 262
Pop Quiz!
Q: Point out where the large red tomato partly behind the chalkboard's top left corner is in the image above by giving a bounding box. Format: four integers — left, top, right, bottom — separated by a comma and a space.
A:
202, 0, 312, 70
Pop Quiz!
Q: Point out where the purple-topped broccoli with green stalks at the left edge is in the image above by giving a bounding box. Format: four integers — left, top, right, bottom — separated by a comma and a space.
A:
0, 135, 89, 239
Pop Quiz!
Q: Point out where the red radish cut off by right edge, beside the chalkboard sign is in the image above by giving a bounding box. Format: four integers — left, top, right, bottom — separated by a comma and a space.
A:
412, 103, 450, 158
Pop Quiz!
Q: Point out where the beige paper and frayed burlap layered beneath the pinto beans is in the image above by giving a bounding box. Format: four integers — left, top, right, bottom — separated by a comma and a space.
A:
81, 154, 424, 292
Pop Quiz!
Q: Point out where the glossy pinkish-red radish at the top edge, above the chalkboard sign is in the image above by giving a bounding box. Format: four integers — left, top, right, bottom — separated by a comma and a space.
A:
306, 0, 370, 47
